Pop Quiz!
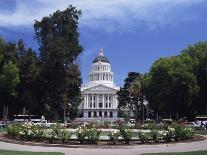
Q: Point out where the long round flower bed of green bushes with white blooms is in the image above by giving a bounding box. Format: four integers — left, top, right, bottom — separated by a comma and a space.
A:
7, 123, 195, 145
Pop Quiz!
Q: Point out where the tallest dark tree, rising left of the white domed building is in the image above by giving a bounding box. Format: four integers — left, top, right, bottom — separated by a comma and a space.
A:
34, 6, 83, 120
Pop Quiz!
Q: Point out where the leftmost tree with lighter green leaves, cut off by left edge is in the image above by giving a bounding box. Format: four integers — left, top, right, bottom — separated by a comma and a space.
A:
0, 38, 19, 119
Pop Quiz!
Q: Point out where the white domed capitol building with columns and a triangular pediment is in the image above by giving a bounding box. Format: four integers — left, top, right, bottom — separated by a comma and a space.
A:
79, 49, 119, 119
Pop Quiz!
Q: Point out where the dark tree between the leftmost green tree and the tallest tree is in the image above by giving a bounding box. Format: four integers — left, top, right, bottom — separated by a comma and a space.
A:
17, 39, 40, 117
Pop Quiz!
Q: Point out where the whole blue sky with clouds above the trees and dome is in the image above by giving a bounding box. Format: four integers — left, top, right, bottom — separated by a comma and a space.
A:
0, 0, 207, 86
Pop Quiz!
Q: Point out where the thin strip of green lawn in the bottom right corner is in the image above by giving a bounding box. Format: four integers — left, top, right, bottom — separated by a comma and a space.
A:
143, 151, 207, 155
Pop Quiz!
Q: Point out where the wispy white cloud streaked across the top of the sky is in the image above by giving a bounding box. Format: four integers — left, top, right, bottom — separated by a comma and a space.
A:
0, 0, 205, 31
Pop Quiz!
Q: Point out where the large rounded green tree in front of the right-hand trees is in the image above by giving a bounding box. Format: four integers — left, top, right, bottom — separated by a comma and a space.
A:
145, 52, 199, 118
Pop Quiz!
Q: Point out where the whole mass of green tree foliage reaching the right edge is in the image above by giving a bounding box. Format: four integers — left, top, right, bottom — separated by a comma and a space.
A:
143, 42, 207, 119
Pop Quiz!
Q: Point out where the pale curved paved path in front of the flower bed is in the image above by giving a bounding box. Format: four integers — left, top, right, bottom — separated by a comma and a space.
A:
0, 136, 207, 155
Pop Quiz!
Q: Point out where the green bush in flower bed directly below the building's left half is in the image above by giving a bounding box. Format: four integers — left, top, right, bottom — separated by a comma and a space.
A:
87, 127, 101, 144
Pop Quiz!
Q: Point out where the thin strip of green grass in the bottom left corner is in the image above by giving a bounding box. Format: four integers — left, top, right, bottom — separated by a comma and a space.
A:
0, 150, 64, 155
